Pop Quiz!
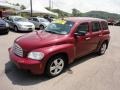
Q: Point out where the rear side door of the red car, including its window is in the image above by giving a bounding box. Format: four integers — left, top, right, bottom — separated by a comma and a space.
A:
91, 21, 102, 50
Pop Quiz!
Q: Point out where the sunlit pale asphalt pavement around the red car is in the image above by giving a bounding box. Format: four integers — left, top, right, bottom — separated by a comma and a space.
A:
0, 26, 120, 90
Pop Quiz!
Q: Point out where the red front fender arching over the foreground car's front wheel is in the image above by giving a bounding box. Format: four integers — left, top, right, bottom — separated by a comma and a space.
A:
35, 44, 75, 63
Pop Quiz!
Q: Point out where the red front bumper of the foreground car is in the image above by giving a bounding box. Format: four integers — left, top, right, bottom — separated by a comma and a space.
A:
9, 48, 44, 74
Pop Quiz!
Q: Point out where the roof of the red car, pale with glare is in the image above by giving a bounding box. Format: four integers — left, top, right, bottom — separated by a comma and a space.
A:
66, 17, 106, 22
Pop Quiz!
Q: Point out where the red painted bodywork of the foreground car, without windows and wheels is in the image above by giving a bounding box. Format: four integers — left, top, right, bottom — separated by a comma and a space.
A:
9, 17, 110, 74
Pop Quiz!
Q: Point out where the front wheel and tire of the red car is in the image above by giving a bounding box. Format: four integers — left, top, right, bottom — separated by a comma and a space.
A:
45, 55, 65, 77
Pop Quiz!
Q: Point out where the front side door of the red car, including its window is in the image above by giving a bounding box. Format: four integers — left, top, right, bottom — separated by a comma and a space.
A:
76, 22, 92, 57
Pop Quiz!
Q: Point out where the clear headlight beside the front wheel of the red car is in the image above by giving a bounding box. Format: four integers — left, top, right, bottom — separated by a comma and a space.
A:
28, 52, 44, 60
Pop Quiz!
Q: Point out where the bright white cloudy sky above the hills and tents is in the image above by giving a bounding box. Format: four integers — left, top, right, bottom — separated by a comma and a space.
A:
0, 0, 120, 14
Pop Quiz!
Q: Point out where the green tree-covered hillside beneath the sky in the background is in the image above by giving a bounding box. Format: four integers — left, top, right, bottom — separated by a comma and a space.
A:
47, 8, 120, 20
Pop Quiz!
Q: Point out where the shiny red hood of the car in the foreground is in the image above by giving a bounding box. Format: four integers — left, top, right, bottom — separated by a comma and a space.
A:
15, 31, 68, 52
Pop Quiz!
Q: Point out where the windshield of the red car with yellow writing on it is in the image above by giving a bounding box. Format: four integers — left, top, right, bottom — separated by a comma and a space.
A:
45, 21, 74, 35
